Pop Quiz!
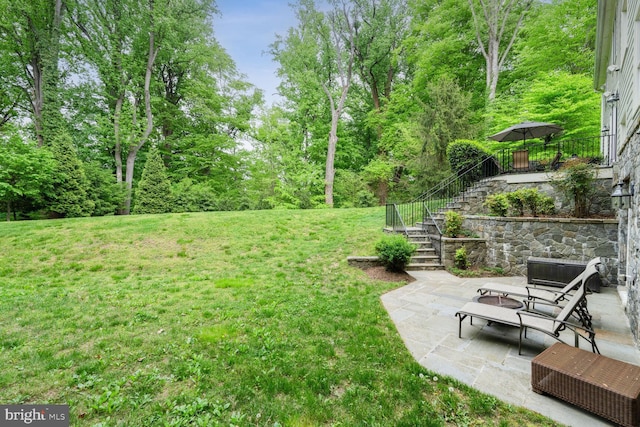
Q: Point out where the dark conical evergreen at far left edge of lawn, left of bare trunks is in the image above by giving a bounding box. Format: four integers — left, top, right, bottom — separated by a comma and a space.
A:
47, 133, 95, 218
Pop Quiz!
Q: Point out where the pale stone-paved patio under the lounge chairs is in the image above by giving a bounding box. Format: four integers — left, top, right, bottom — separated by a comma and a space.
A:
382, 271, 640, 427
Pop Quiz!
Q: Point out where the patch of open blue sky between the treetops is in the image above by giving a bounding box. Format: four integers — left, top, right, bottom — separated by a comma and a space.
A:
213, 0, 296, 103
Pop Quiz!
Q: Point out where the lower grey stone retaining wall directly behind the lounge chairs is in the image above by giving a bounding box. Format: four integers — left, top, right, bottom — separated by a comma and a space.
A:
454, 216, 618, 284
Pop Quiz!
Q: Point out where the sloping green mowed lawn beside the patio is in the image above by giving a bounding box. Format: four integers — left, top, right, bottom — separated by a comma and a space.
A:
0, 208, 552, 426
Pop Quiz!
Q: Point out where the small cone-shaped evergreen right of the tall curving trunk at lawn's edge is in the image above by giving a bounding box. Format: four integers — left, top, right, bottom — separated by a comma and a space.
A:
134, 147, 173, 214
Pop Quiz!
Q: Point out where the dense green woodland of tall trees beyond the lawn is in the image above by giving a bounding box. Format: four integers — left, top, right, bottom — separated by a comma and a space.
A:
0, 0, 599, 218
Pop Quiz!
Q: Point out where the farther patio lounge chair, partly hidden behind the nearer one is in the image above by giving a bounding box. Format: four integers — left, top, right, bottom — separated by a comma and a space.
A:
478, 257, 602, 308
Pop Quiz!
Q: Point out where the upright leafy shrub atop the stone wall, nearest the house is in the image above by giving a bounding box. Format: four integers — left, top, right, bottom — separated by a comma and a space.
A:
551, 159, 597, 218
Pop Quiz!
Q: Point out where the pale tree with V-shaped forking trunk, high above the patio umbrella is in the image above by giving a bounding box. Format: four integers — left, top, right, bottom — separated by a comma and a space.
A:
468, 0, 533, 102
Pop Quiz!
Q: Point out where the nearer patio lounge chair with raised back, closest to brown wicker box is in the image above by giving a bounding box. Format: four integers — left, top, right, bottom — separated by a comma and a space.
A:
456, 266, 600, 354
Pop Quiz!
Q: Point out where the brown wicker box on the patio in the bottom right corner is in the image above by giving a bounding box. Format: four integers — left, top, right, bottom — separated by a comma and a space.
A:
531, 343, 640, 427
